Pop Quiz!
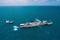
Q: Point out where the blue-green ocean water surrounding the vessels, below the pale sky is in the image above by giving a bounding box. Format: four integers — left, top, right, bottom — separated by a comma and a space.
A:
0, 6, 60, 40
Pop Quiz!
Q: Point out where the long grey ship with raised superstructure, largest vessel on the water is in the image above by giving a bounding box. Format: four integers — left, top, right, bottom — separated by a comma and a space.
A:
20, 19, 53, 28
